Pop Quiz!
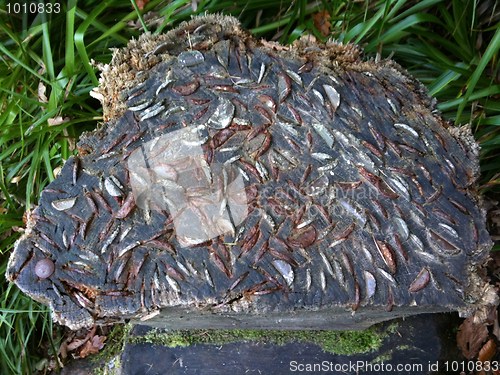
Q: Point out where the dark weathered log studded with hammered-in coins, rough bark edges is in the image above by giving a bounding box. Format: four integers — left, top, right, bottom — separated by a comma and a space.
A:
7, 16, 496, 329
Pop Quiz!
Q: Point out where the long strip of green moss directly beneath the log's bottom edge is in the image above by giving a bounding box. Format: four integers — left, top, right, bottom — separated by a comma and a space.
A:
130, 327, 389, 355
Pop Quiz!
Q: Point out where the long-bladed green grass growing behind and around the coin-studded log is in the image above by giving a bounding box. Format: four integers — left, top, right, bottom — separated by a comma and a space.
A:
0, 0, 500, 374
